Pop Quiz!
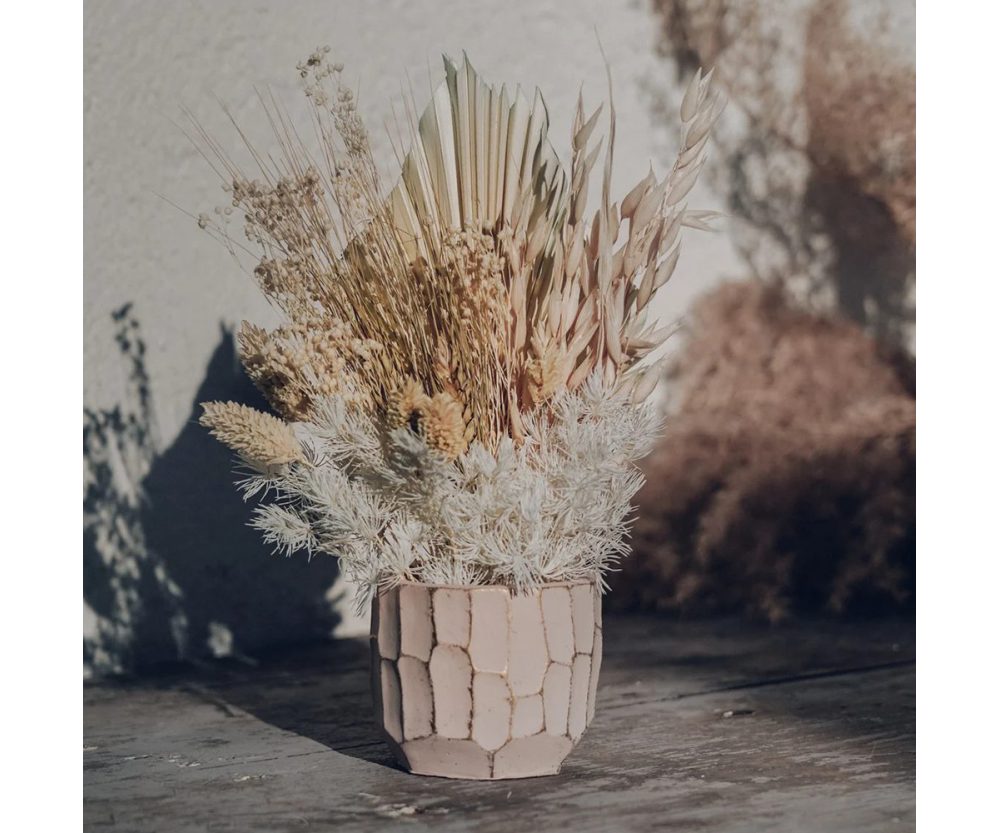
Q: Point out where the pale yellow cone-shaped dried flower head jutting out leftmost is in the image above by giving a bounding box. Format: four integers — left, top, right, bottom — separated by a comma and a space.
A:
199, 402, 304, 466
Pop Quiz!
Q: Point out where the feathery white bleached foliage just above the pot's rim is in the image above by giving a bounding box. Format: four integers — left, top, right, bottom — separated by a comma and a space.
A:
241, 376, 657, 604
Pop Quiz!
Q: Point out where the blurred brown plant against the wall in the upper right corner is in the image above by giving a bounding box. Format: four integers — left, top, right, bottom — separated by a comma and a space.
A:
653, 0, 916, 349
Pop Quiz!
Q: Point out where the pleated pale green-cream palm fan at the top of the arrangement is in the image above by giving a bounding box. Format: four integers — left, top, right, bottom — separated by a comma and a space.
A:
382, 57, 567, 446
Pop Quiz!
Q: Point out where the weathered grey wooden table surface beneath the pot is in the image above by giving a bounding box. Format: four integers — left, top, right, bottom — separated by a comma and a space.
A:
83, 616, 916, 833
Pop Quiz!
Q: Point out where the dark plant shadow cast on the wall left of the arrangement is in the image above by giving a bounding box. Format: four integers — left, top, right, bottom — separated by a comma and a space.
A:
83, 304, 338, 674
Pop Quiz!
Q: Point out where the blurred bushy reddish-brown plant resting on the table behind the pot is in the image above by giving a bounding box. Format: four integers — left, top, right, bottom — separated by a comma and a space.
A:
612, 282, 915, 620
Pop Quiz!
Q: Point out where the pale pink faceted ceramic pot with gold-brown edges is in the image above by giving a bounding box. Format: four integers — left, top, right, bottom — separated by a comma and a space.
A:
371, 582, 602, 780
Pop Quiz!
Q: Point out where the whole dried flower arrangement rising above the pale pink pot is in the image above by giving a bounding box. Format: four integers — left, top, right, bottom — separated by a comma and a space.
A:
193, 50, 723, 603
